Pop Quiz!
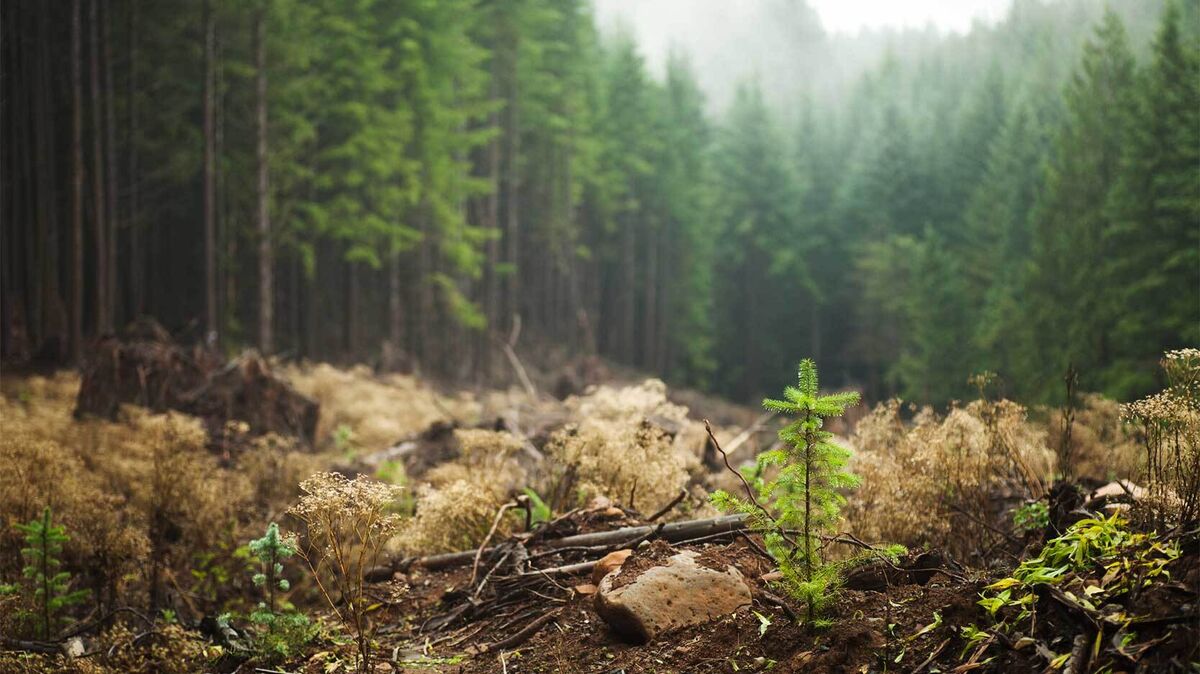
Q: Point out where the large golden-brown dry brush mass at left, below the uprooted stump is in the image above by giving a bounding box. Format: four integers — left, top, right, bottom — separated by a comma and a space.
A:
0, 374, 298, 619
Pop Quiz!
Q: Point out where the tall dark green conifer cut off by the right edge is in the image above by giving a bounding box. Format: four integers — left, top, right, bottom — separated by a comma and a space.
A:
1103, 1, 1200, 399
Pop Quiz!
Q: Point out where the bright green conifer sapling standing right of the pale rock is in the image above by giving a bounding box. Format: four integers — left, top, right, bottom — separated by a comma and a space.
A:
713, 359, 859, 619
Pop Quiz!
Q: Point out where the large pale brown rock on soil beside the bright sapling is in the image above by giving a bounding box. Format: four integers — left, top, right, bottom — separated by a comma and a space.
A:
595, 550, 750, 643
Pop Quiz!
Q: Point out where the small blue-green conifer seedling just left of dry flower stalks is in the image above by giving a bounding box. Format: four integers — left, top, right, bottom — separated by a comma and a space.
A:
250, 522, 314, 660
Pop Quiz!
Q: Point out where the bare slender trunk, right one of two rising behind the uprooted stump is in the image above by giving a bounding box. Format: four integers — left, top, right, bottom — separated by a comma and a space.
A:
254, 7, 275, 354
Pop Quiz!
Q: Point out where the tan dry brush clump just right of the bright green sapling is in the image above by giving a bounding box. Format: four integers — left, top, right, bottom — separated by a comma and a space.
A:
846, 393, 1055, 555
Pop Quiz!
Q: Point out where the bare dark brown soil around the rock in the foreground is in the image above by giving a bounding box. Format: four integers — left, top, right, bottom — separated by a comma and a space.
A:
352, 530, 1200, 674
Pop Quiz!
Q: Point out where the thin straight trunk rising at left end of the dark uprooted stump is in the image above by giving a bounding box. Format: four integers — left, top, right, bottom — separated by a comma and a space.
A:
71, 0, 83, 363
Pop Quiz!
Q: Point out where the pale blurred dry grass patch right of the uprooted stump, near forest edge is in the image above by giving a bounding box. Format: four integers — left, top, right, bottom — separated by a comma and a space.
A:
282, 363, 479, 451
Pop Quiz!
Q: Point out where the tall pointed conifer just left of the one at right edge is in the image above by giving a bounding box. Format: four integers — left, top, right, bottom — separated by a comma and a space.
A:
1022, 11, 1134, 399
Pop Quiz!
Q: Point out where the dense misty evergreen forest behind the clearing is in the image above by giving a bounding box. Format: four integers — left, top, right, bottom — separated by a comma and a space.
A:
0, 0, 1200, 403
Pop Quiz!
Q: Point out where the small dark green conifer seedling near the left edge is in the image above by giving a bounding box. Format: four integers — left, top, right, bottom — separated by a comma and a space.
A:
0, 507, 88, 639
